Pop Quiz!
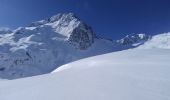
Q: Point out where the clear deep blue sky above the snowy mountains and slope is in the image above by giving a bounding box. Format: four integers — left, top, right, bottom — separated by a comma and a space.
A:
0, 0, 170, 39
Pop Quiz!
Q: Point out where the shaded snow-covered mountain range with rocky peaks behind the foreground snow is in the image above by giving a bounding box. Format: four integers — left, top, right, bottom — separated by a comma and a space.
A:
0, 13, 149, 79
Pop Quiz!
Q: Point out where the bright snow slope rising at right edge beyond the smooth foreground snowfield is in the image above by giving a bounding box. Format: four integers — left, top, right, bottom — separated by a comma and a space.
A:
138, 33, 170, 49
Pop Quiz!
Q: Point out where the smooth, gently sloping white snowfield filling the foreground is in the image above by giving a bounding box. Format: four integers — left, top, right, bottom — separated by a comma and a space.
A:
0, 49, 170, 100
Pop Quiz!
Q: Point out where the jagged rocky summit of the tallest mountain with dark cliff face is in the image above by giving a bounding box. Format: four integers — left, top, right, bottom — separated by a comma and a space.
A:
29, 13, 96, 49
